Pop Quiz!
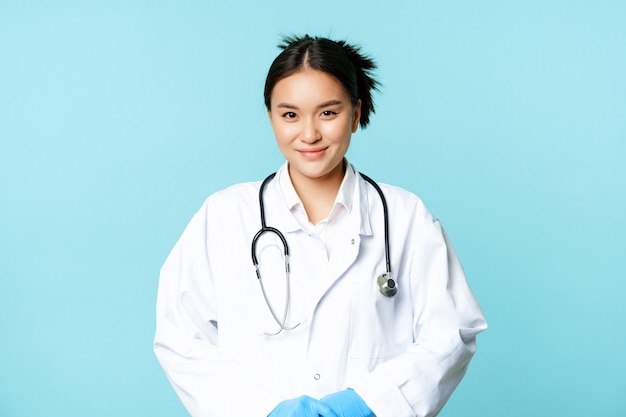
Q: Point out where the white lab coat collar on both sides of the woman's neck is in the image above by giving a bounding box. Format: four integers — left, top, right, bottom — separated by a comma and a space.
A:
268, 161, 372, 236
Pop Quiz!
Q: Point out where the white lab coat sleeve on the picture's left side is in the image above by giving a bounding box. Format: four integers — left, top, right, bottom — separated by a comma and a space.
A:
154, 199, 284, 417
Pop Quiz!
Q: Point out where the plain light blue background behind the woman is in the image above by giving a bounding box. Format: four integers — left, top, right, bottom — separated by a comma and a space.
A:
0, 0, 626, 417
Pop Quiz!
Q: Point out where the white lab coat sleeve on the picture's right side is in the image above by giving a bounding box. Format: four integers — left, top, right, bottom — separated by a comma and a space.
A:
353, 220, 487, 417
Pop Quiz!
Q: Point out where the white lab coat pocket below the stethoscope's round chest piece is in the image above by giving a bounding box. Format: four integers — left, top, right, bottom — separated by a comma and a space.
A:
350, 293, 404, 359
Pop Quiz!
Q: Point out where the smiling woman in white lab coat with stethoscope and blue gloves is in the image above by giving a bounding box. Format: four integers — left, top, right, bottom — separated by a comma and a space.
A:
154, 36, 486, 417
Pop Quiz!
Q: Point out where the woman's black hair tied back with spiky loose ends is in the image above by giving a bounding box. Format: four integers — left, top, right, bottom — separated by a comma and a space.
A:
264, 35, 379, 128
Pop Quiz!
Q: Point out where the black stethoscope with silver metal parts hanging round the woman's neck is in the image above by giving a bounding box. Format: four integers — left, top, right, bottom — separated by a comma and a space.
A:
252, 172, 398, 336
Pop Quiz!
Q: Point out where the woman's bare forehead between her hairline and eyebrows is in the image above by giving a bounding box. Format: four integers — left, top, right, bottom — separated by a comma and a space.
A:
271, 69, 349, 106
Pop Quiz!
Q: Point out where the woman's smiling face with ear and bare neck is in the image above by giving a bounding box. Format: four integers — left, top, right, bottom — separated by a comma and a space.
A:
269, 69, 361, 224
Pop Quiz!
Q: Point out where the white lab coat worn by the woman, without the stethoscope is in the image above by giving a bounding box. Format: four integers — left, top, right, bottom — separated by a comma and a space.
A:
154, 162, 486, 417
